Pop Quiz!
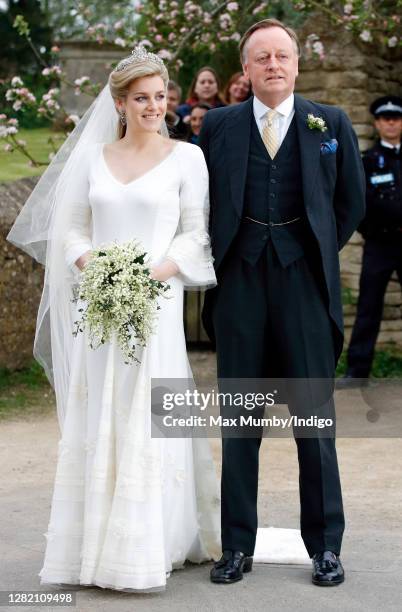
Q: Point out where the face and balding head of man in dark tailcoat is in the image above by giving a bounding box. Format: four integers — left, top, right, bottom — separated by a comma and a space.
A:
243, 26, 299, 104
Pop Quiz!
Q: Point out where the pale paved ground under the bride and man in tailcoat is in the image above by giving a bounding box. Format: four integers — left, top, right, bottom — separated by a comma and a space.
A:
0, 354, 402, 612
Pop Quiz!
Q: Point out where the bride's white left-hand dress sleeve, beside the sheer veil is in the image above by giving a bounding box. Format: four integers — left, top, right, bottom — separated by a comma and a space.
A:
63, 148, 92, 272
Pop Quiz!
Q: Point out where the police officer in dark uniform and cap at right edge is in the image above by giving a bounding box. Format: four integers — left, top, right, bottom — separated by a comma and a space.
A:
337, 96, 402, 388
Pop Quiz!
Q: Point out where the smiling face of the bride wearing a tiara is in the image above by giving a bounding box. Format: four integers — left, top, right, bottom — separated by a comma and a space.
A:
118, 75, 167, 132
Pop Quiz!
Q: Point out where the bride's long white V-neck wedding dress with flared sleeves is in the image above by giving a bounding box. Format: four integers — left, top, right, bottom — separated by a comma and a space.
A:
39, 142, 221, 591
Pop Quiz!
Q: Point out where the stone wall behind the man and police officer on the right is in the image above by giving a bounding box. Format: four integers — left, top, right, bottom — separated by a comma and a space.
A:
296, 18, 402, 346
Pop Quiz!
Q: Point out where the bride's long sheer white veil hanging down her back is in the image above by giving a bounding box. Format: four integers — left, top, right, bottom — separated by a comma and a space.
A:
7, 85, 168, 430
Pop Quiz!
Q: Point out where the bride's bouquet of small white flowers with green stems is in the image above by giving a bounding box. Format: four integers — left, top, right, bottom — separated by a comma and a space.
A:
73, 241, 169, 363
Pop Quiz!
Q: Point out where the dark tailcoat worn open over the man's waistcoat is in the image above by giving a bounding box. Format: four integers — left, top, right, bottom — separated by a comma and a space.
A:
199, 94, 365, 360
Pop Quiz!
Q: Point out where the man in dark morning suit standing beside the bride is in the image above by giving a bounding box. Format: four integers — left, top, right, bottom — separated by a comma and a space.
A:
199, 19, 365, 585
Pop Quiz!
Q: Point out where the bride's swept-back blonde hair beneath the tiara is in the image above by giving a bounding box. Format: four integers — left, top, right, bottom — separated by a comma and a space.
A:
108, 59, 169, 139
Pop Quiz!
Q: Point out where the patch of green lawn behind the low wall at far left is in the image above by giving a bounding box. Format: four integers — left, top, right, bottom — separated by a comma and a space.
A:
0, 127, 62, 182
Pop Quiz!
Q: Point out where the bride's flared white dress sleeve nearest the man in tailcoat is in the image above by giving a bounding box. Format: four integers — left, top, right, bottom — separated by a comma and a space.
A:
166, 143, 217, 290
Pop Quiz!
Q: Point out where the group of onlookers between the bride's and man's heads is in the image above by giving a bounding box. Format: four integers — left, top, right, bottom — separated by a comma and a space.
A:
166, 66, 251, 144
